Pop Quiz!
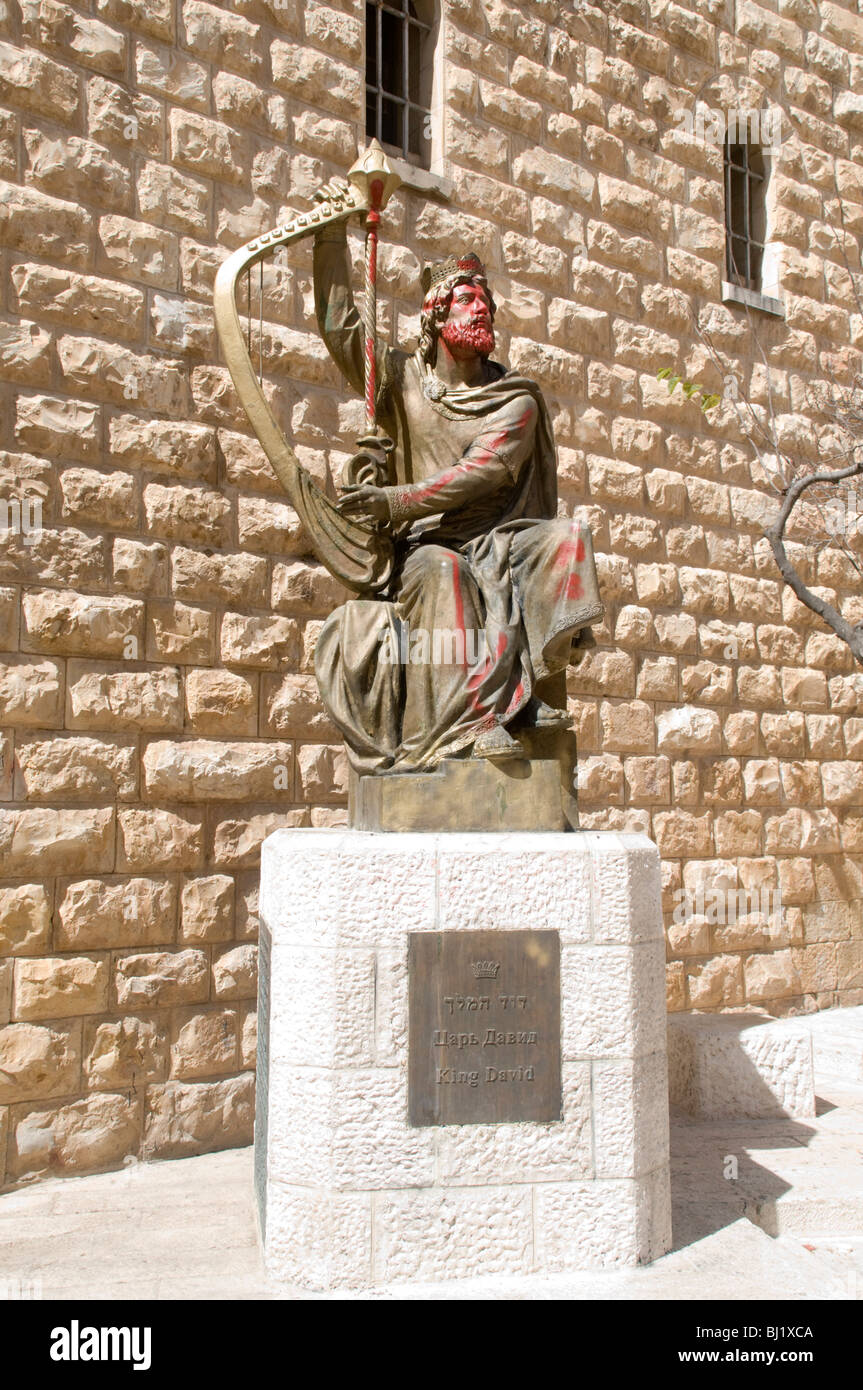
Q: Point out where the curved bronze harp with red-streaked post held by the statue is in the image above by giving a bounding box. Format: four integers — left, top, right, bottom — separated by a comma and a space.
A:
214, 140, 400, 595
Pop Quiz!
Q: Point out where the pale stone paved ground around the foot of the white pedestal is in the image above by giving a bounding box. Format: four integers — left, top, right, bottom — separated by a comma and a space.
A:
0, 1079, 863, 1300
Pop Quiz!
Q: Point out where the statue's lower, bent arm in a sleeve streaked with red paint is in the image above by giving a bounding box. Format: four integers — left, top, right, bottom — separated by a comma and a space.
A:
384, 396, 538, 525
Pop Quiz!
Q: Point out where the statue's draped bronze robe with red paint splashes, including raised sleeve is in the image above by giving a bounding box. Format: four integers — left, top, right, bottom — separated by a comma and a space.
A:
314, 229, 602, 773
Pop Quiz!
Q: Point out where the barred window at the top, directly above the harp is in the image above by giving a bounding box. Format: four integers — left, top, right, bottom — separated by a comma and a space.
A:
365, 0, 435, 167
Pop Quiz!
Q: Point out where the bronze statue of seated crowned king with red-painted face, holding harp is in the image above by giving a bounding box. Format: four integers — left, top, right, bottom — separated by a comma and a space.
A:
217, 146, 602, 795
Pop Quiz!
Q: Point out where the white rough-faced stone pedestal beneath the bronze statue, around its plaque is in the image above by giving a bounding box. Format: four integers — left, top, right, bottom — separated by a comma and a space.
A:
256, 830, 671, 1290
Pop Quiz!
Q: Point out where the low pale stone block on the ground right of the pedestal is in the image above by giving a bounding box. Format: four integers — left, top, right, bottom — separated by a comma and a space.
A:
668, 1012, 814, 1119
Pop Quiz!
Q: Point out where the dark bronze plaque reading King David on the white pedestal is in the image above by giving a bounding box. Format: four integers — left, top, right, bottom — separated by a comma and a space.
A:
407, 931, 560, 1125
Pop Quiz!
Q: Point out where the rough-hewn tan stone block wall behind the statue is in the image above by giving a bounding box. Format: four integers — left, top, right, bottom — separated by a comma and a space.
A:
0, 0, 863, 1184
